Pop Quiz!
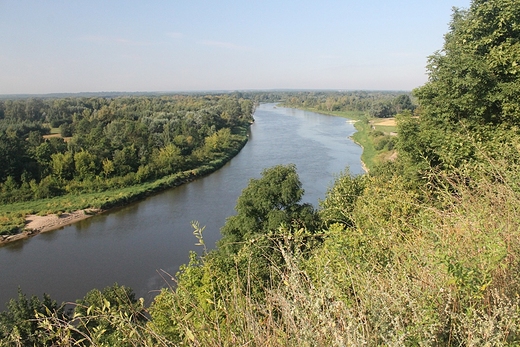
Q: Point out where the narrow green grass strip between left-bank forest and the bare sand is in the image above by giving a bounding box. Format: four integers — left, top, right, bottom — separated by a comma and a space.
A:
0, 128, 247, 239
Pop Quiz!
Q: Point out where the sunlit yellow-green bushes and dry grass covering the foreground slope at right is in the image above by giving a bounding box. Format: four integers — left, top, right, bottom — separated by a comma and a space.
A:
141, 162, 520, 346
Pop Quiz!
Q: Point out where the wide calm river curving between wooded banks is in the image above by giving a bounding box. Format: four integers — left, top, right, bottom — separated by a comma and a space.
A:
0, 104, 363, 310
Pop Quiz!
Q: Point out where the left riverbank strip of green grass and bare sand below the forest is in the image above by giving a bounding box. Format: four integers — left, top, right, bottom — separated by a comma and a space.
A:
0, 128, 248, 246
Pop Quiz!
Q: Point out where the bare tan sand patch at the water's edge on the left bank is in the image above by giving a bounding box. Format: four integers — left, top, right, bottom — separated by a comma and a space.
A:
0, 209, 101, 245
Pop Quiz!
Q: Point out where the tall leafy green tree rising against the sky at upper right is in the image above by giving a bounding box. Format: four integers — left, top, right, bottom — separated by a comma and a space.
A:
406, 0, 520, 167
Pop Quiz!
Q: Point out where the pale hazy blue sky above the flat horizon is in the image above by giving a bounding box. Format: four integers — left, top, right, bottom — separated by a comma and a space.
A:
0, 0, 470, 94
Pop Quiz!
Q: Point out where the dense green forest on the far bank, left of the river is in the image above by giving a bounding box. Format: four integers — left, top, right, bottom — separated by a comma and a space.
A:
0, 95, 254, 203
